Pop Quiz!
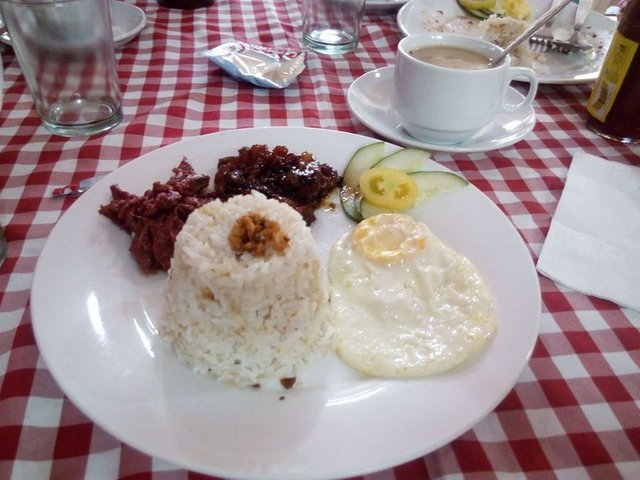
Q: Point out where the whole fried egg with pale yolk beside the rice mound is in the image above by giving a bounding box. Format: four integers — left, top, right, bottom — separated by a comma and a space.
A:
328, 213, 496, 377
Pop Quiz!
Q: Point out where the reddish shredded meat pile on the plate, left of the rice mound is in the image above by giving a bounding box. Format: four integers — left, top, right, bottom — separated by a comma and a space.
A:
99, 159, 212, 273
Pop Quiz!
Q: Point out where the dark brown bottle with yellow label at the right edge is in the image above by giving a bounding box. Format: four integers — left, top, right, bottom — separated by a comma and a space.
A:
587, 0, 640, 143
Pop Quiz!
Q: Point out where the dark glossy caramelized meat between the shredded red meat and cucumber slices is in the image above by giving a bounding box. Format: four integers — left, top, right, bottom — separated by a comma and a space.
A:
214, 145, 341, 225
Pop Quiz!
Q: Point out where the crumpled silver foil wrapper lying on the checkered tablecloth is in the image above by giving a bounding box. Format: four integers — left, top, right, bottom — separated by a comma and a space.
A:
202, 42, 305, 88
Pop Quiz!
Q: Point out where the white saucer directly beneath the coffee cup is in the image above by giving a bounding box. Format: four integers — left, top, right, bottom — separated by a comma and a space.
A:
347, 66, 536, 152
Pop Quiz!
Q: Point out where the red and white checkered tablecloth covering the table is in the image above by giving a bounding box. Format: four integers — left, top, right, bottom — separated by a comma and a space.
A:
0, 0, 640, 480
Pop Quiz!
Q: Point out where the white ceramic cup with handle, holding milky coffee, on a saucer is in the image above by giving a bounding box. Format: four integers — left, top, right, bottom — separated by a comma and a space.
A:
392, 33, 538, 144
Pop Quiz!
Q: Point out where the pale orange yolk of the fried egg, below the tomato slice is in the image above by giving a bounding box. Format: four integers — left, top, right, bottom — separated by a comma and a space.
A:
351, 213, 427, 263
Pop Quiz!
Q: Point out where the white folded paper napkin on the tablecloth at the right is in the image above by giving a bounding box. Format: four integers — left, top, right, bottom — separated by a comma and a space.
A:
537, 153, 640, 311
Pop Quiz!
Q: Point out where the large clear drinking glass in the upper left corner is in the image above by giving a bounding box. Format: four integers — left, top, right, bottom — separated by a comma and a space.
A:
0, 0, 122, 136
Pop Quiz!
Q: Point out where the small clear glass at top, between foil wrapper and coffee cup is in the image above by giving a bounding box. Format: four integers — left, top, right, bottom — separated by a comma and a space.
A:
302, 0, 365, 55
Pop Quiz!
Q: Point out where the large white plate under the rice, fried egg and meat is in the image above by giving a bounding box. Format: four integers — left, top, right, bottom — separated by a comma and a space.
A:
31, 127, 541, 480
